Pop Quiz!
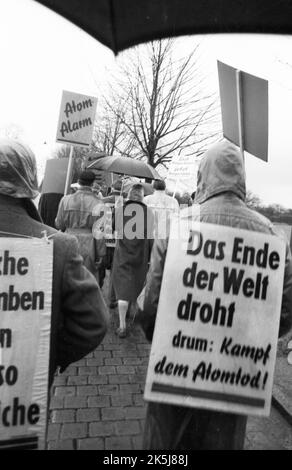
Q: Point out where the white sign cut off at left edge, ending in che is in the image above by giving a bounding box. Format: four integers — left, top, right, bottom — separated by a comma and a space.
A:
0, 238, 53, 450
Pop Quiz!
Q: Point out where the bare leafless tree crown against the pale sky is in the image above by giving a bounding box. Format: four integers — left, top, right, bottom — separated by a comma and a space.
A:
101, 39, 219, 167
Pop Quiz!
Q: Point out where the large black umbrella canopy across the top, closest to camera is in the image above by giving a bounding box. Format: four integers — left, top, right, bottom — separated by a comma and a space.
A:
33, 0, 292, 54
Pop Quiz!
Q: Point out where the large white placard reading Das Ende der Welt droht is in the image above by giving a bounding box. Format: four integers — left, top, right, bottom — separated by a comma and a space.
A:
145, 220, 285, 416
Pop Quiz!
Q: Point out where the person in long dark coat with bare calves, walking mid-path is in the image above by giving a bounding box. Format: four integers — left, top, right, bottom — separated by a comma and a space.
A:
112, 184, 154, 338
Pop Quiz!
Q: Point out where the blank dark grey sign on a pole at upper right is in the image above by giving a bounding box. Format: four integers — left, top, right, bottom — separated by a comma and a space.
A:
217, 61, 269, 162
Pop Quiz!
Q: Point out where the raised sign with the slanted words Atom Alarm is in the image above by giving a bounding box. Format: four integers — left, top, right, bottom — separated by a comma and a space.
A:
56, 90, 97, 147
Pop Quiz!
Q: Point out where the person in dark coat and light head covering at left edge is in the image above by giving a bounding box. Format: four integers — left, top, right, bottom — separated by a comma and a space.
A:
0, 139, 108, 387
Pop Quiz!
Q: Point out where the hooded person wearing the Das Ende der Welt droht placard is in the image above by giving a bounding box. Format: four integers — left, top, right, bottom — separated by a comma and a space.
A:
137, 140, 292, 450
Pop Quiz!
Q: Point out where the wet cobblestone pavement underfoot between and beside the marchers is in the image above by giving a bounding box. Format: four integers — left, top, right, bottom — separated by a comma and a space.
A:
48, 278, 292, 450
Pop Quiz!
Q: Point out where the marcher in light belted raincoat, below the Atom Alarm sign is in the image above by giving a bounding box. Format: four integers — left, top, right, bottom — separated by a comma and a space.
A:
55, 170, 106, 286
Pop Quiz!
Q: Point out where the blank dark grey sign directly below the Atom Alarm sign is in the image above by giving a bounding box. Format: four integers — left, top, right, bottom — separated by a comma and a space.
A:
42, 158, 69, 194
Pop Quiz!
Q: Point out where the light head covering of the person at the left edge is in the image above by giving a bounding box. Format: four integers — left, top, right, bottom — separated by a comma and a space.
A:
0, 139, 38, 199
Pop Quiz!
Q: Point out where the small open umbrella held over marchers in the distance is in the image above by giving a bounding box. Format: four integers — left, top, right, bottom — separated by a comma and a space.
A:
87, 157, 161, 180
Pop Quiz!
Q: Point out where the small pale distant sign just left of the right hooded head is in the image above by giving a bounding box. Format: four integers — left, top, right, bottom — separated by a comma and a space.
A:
166, 155, 198, 194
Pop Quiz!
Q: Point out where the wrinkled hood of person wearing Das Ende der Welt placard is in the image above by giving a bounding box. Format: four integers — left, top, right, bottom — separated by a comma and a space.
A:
195, 140, 246, 204
